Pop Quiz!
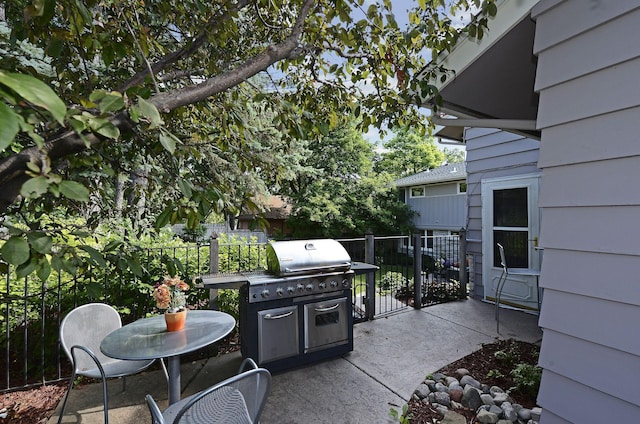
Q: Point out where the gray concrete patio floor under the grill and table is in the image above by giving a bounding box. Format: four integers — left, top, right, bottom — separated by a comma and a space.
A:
48, 300, 542, 424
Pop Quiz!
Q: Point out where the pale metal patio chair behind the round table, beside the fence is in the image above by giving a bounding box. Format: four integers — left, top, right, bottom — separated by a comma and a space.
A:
58, 303, 158, 424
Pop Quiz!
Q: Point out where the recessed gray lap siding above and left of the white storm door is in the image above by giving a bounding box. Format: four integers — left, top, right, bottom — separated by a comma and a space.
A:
465, 128, 540, 299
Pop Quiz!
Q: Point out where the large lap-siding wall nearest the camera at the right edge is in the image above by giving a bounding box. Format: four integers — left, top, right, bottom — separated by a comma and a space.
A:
532, 0, 640, 424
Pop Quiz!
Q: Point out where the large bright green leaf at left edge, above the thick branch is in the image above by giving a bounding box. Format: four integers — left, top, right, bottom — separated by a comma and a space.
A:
0, 71, 67, 124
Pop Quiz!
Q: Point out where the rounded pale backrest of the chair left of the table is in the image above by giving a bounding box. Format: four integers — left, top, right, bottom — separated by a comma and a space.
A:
60, 303, 122, 374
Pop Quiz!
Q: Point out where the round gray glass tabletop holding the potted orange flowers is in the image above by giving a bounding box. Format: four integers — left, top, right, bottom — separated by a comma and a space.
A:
100, 310, 236, 360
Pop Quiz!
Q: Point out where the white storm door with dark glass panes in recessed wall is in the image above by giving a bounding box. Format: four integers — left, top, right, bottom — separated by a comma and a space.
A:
482, 175, 541, 310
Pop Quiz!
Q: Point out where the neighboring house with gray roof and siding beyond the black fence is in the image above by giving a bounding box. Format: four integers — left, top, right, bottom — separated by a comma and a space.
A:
395, 162, 467, 240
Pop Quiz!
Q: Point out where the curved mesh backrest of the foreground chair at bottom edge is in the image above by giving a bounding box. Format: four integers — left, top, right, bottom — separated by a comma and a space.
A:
174, 362, 271, 424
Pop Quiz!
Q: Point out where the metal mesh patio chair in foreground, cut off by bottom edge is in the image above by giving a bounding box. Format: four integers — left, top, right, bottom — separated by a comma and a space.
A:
146, 358, 271, 424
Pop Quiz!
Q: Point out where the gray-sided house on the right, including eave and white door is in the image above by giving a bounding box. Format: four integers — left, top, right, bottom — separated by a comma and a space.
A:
420, 0, 640, 424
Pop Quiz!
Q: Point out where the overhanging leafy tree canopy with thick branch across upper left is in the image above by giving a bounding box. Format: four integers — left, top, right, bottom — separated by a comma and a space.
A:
0, 0, 495, 278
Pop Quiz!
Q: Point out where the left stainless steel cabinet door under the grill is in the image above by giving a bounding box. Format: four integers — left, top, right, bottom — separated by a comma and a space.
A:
258, 305, 300, 364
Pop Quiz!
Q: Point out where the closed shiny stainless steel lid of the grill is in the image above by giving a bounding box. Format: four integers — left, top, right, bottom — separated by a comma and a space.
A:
267, 239, 351, 276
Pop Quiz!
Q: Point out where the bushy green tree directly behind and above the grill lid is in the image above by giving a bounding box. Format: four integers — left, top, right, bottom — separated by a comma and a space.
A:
283, 118, 413, 238
